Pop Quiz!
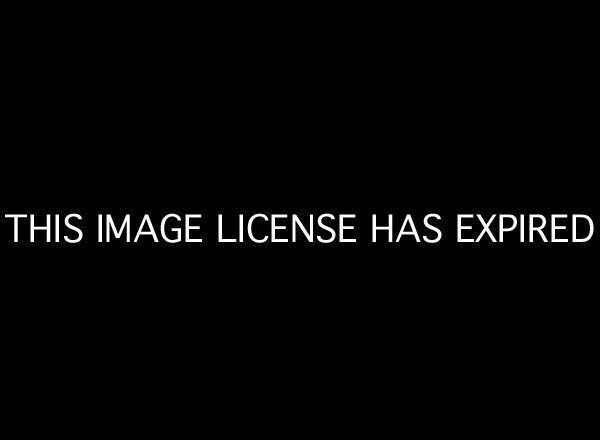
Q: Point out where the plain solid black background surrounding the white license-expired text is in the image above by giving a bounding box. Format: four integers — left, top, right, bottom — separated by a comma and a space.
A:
1, 5, 598, 433
